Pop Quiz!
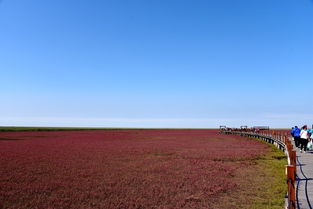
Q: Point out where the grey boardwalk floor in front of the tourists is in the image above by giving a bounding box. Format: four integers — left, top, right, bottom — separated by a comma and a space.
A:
296, 145, 313, 209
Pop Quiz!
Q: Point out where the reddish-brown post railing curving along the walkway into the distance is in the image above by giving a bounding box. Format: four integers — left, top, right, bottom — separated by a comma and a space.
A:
220, 128, 297, 209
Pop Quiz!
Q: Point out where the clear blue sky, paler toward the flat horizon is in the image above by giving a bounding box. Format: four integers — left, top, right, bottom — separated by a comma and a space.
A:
0, 0, 313, 128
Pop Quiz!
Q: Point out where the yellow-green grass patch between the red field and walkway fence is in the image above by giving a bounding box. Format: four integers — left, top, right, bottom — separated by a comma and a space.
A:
214, 139, 287, 209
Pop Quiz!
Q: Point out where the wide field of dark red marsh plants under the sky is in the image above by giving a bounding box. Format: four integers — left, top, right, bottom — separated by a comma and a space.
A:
0, 129, 267, 209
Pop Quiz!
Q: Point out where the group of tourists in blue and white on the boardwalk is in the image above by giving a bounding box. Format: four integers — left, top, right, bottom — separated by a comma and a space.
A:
290, 125, 313, 153
